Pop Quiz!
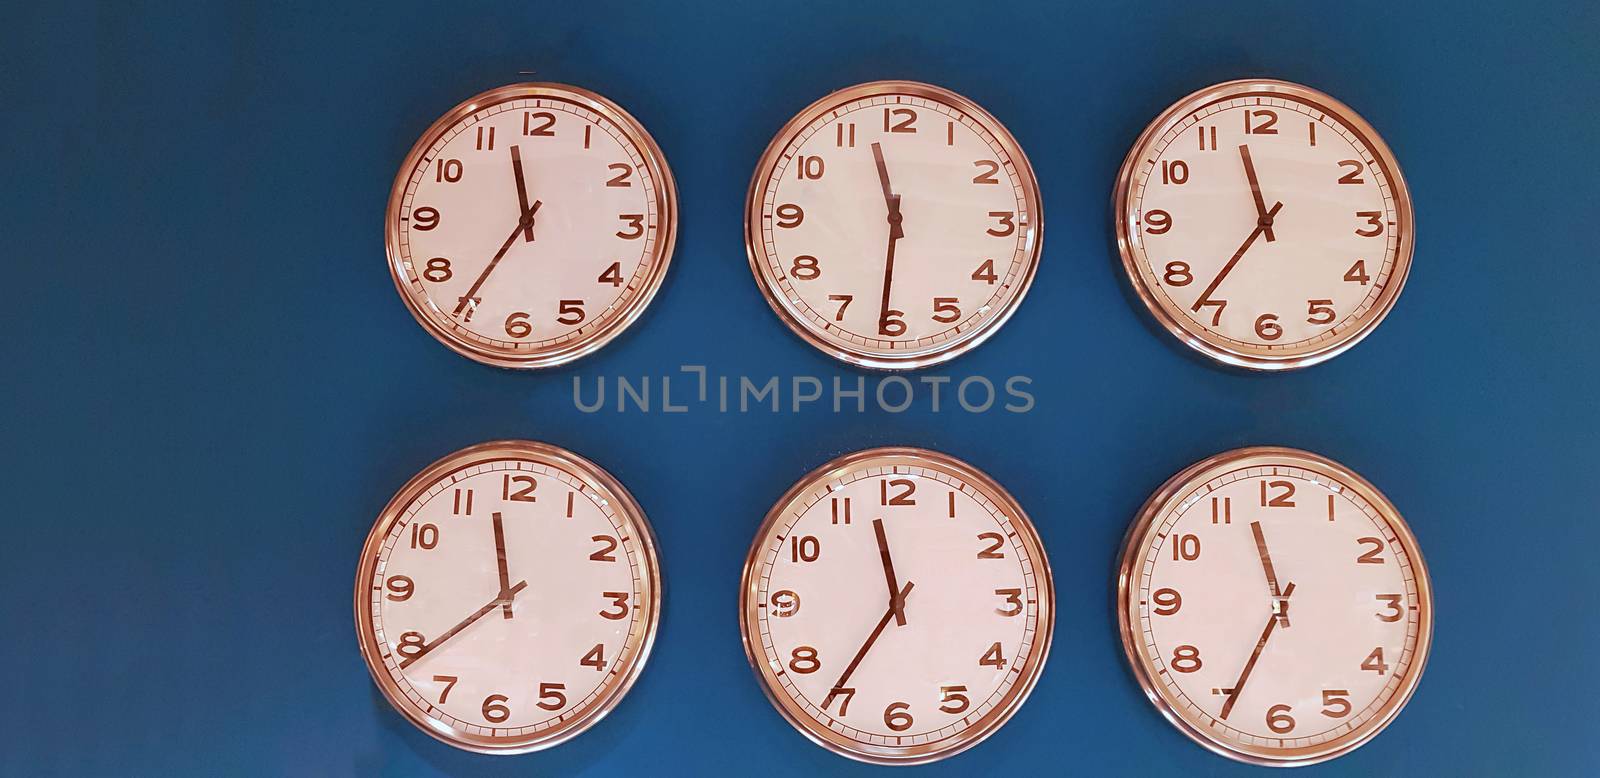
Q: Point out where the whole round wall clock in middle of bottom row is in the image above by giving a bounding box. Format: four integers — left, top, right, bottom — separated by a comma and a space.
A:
739, 448, 1054, 764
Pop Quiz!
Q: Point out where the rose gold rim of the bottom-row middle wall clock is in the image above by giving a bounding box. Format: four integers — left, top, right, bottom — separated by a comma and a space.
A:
739, 447, 1056, 765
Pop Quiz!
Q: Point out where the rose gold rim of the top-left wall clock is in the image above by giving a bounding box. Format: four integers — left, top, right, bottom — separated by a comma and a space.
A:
384, 82, 678, 370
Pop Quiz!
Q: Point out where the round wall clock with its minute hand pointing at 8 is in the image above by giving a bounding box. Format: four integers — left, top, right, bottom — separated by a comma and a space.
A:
355, 440, 661, 754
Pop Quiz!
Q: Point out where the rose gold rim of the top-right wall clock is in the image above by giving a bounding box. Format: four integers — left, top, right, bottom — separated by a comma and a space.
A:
1112, 78, 1416, 371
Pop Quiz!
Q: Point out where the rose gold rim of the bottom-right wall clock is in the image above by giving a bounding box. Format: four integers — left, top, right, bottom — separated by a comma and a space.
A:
1117, 447, 1434, 767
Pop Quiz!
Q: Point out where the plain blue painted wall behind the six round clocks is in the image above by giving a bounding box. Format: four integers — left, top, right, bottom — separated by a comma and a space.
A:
0, 0, 1600, 775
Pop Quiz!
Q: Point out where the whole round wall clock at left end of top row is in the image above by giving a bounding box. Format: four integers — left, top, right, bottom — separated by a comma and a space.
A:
386, 83, 677, 368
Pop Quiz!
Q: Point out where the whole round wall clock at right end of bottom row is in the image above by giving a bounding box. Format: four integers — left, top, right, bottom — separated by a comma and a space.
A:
1117, 448, 1434, 765
